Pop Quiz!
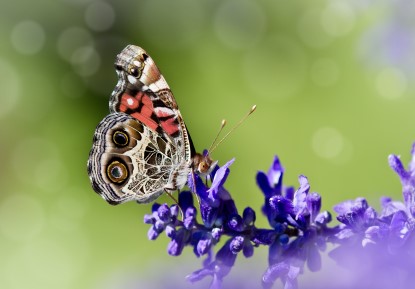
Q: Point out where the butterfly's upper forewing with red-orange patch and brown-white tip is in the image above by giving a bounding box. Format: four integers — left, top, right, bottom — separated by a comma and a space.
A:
110, 45, 195, 161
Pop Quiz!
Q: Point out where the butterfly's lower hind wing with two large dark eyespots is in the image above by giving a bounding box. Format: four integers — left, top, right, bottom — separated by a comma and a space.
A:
88, 113, 180, 205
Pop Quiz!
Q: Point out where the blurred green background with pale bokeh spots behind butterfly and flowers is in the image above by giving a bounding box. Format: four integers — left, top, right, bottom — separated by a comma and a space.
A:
0, 0, 415, 289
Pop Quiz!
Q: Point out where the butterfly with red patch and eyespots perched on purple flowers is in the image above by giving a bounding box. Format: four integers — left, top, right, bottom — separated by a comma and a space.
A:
87, 45, 216, 205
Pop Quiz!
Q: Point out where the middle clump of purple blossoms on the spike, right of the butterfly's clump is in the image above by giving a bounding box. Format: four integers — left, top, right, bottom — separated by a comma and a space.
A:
257, 163, 331, 288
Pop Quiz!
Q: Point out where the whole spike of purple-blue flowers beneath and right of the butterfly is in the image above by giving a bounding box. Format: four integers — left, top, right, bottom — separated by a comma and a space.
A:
144, 144, 415, 288
